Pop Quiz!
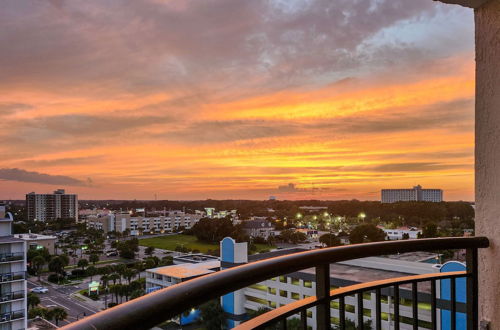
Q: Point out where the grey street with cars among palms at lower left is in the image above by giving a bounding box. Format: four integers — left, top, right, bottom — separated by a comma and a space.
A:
27, 281, 99, 326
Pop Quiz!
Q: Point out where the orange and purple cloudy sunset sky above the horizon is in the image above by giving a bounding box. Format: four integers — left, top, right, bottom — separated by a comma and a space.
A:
0, 0, 474, 200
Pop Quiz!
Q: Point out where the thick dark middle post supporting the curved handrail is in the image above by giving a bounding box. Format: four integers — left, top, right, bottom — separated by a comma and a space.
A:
316, 264, 330, 330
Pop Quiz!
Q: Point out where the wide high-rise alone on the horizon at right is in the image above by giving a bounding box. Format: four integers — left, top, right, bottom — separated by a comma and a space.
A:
382, 185, 443, 203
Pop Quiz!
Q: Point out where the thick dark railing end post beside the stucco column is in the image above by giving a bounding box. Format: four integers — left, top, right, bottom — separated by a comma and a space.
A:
465, 249, 479, 330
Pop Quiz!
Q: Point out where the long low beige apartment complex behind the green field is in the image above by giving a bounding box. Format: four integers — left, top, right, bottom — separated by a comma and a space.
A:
86, 211, 204, 236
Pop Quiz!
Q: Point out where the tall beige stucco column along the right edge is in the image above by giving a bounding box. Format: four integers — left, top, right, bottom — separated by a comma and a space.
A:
475, 0, 500, 329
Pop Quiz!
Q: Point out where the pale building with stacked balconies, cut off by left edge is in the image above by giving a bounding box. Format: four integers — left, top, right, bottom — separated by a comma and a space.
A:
0, 205, 27, 330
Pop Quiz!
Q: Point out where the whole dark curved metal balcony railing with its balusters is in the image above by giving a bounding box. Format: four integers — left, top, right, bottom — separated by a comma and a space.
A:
59, 237, 489, 330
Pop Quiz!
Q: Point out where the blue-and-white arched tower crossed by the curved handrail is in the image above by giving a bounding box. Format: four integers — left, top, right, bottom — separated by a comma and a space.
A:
220, 237, 248, 328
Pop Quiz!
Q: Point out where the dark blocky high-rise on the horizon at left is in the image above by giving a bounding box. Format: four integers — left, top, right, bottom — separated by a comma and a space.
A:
26, 189, 78, 221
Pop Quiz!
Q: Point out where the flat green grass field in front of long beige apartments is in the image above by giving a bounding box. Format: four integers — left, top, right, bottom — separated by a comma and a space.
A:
139, 235, 274, 253
